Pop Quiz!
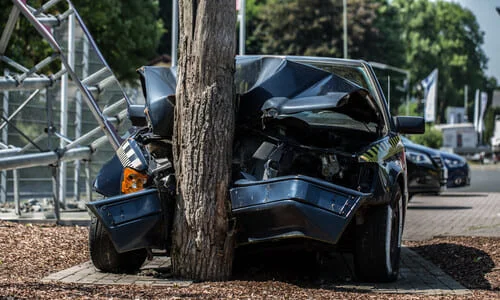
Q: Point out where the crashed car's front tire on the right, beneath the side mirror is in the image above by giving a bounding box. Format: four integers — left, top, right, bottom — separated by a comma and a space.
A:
354, 185, 404, 282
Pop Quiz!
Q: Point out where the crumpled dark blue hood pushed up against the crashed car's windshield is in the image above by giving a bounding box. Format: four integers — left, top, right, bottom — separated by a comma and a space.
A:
235, 56, 385, 132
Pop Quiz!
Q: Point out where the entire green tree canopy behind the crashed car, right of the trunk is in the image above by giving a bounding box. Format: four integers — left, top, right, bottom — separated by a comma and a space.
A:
247, 0, 496, 122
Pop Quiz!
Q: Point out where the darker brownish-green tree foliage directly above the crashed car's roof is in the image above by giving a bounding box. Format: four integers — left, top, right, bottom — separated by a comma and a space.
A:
247, 0, 403, 64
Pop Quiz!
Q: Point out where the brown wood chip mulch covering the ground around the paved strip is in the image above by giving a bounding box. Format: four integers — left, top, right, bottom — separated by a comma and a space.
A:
0, 221, 500, 299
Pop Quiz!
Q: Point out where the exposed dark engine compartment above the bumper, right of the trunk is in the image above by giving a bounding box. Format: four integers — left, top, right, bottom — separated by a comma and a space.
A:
233, 122, 376, 192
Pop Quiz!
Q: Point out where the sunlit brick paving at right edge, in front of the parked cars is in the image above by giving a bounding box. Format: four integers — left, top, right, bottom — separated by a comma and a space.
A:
403, 190, 500, 240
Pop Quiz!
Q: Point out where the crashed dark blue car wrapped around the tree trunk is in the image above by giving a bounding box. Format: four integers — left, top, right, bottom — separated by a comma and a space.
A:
88, 56, 424, 281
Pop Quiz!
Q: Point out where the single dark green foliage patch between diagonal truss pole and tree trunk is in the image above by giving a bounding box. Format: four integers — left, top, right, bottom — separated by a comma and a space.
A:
73, 0, 163, 80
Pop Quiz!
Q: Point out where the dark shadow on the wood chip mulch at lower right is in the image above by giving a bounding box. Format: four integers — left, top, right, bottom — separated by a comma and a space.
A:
410, 243, 500, 291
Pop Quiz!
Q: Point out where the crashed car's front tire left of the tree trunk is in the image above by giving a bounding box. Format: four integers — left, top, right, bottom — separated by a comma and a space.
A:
89, 217, 147, 273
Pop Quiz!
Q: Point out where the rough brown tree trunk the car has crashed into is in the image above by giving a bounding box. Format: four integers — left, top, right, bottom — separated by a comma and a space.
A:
172, 0, 236, 280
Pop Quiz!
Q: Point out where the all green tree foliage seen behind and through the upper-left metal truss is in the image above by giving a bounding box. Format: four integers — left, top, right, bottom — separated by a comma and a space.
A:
0, 0, 162, 81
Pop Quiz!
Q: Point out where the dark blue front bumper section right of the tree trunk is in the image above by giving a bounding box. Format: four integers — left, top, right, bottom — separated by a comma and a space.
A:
230, 175, 372, 245
